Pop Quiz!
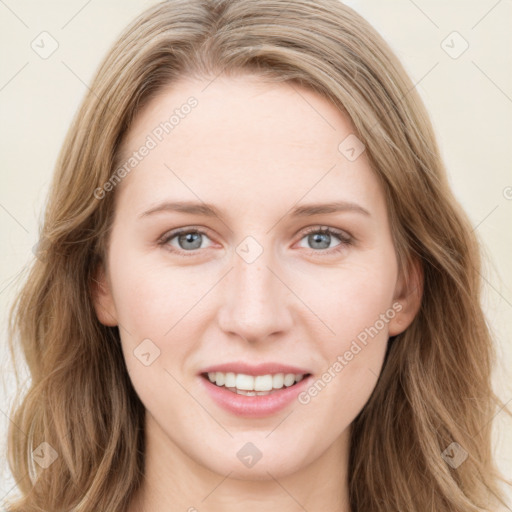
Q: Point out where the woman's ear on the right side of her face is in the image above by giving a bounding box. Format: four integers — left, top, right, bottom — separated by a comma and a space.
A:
388, 258, 424, 336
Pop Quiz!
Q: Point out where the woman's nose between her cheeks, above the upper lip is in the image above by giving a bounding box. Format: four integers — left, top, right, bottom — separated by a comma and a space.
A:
218, 244, 293, 343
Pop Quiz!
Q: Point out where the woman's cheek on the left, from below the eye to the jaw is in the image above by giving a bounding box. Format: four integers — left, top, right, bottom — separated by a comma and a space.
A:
107, 255, 204, 396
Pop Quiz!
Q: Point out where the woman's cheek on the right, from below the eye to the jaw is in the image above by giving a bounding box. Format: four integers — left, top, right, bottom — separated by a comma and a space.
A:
299, 252, 397, 412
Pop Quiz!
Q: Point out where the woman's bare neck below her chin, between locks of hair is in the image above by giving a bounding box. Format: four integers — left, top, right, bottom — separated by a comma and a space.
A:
127, 412, 350, 512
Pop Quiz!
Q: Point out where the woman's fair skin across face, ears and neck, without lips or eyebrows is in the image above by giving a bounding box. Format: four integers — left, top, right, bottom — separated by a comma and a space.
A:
94, 75, 419, 512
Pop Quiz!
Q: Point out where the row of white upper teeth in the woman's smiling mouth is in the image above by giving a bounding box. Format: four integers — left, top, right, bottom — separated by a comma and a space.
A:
208, 372, 304, 390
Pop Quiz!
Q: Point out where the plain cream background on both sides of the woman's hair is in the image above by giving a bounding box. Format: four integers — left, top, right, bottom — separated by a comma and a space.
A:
0, 0, 512, 504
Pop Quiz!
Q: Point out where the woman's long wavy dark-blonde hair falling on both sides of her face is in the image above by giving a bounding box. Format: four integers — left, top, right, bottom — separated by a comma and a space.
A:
8, 0, 504, 512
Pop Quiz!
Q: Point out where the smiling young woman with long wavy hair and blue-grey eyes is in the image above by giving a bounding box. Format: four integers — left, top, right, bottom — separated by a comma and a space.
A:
3, 0, 504, 512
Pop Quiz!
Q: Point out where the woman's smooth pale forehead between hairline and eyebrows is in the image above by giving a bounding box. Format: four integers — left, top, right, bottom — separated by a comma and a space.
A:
113, 76, 384, 218
